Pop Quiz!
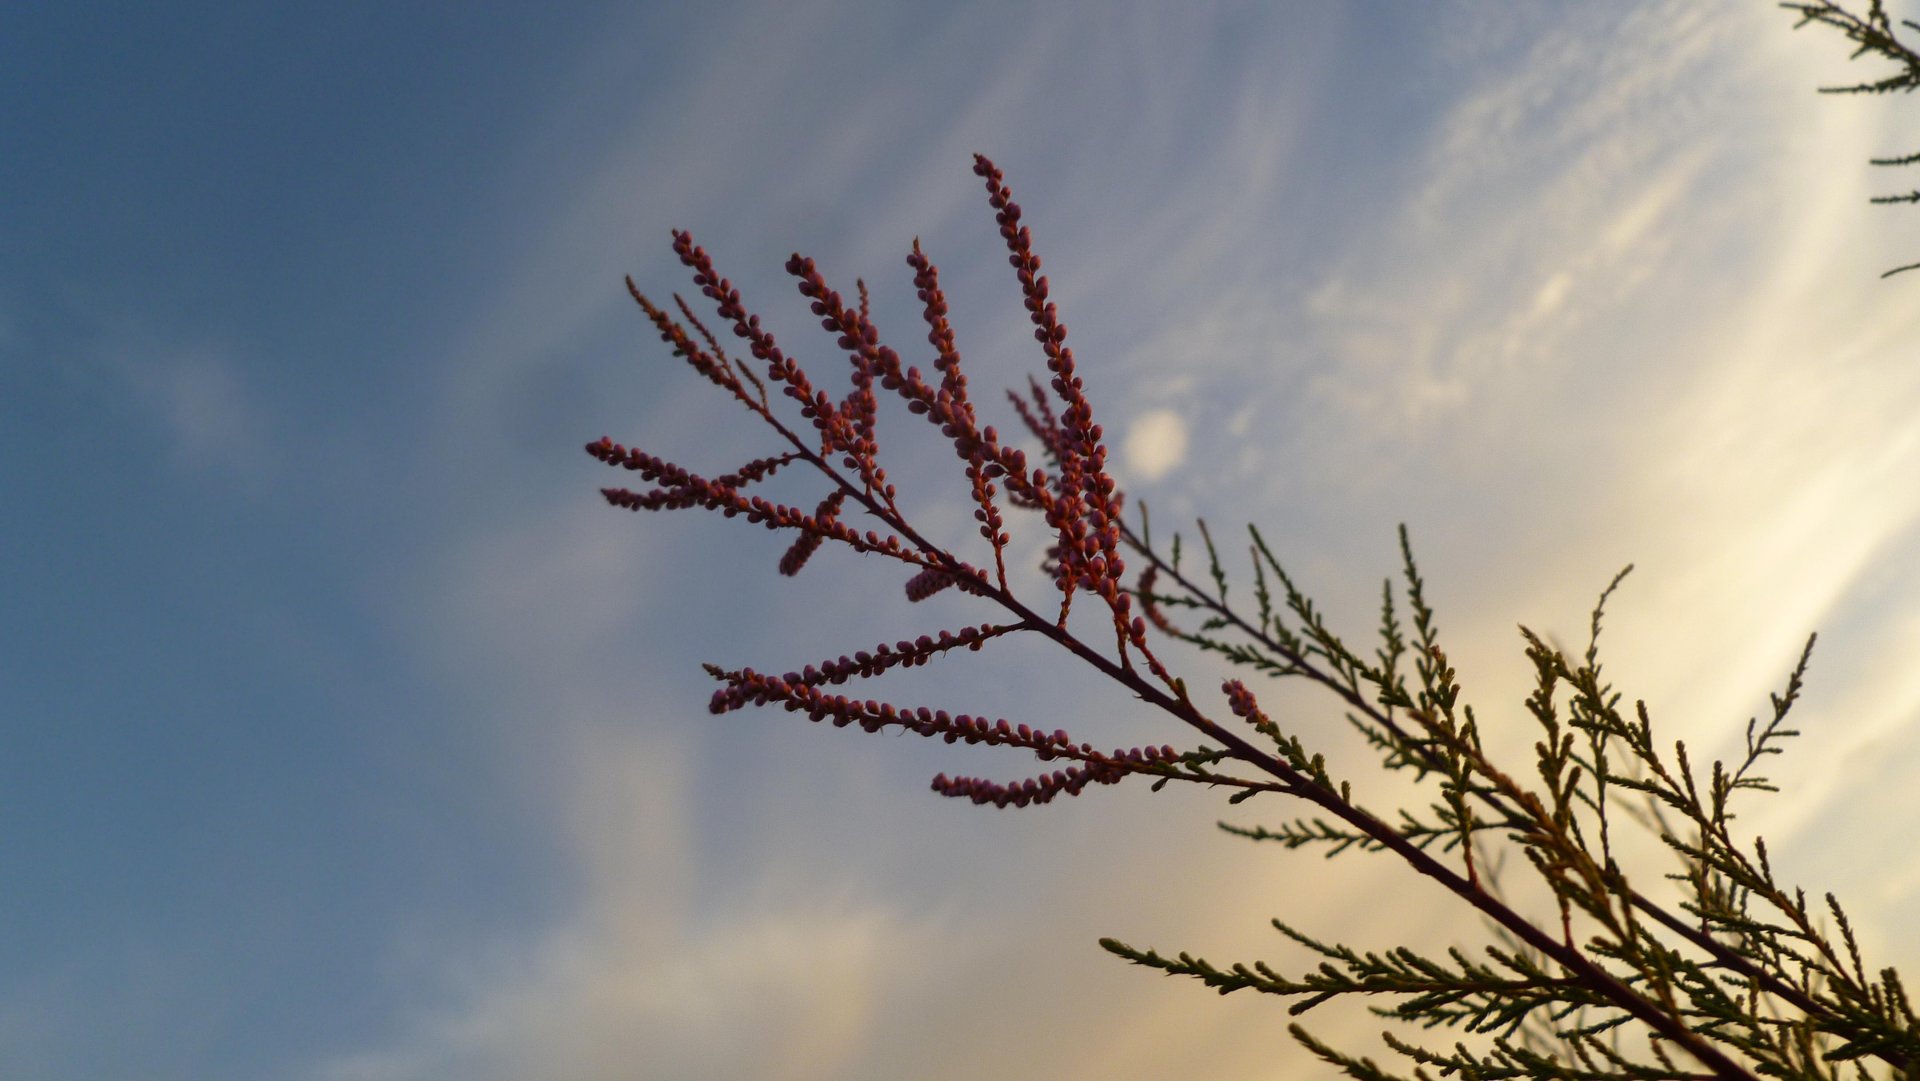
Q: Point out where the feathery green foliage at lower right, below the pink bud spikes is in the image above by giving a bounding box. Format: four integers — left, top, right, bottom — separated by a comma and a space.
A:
1100, 510, 1920, 1079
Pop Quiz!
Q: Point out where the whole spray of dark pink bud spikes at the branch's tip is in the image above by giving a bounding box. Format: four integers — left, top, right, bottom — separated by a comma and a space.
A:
586, 157, 1231, 806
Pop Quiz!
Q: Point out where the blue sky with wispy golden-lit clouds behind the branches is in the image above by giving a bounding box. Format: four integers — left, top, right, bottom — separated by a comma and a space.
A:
0, 0, 1920, 1081
